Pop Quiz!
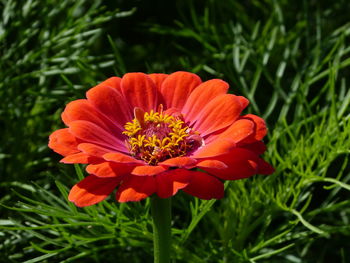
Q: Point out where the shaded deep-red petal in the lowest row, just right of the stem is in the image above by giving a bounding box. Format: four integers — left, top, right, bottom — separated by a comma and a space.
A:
183, 172, 224, 200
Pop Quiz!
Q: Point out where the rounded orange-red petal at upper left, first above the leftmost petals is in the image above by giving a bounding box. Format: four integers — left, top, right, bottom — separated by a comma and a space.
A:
61, 100, 121, 134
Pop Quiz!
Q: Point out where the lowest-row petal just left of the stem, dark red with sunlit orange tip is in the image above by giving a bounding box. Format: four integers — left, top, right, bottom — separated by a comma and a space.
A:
116, 175, 156, 203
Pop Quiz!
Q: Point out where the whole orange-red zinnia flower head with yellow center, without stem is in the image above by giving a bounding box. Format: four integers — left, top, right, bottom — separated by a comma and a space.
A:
49, 72, 273, 207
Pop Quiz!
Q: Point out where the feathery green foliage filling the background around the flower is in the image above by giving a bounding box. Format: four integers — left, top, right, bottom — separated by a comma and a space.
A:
0, 0, 350, 263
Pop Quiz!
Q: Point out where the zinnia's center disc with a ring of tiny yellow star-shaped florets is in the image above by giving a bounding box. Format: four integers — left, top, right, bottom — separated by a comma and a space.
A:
123, 105, 203, 165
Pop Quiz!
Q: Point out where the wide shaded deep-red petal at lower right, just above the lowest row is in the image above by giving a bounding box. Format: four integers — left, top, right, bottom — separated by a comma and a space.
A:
202, 148, 259, 180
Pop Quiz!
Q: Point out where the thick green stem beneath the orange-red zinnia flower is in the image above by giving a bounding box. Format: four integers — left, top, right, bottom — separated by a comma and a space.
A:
151, 195, 171, 263
